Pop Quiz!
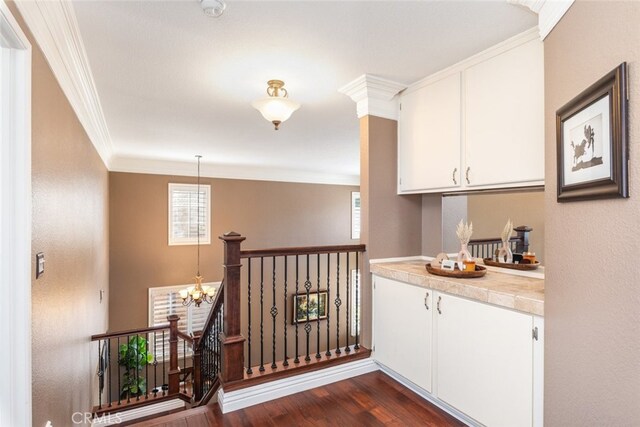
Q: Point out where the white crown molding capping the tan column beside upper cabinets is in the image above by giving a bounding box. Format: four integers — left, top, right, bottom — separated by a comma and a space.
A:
338, 74, 407, 120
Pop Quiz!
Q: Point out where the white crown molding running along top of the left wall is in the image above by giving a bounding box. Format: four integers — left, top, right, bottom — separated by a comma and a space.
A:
16, 0, 113, 169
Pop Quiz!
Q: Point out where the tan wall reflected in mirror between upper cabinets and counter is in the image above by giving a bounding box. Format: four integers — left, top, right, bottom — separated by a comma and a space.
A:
464, 191, 545, 263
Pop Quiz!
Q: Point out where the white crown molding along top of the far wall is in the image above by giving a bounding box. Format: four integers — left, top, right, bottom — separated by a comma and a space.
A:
109, 156, 360, 186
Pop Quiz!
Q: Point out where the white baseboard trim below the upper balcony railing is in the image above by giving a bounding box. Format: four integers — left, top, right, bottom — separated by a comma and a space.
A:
218, 358, 380, 414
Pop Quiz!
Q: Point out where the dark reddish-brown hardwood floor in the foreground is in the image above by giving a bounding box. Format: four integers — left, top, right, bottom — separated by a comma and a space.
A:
134, 371, 464, 427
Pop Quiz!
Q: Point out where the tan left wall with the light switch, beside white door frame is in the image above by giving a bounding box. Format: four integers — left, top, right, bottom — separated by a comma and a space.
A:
9, 3, 109, 426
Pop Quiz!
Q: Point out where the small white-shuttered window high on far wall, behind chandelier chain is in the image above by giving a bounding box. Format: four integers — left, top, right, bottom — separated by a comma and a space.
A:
169, 184, 211, 246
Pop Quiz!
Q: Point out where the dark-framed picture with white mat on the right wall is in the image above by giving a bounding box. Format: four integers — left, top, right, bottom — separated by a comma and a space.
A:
556, 62, 629, 202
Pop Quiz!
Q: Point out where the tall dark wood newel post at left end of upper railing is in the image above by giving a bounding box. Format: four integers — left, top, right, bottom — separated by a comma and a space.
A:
220, 231, 245, 384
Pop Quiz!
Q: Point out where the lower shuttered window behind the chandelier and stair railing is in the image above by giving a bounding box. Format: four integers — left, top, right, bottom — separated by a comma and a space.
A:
149, 282, 220, 361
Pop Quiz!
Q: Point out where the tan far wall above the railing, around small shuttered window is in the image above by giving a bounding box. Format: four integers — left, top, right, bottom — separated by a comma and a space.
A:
109, 172, 359, 332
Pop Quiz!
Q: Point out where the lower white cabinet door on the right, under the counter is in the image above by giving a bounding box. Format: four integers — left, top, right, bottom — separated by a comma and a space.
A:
434, 293, 533, 427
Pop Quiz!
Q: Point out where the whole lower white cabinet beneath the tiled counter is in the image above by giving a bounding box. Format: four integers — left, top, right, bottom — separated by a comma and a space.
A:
373, 275, 544, 427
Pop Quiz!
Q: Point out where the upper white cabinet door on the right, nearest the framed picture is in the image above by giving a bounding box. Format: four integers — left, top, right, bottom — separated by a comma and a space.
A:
463, 40, 544, 186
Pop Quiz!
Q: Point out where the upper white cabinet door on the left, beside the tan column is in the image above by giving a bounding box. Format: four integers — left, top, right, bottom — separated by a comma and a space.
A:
398, 73, 461, 192
